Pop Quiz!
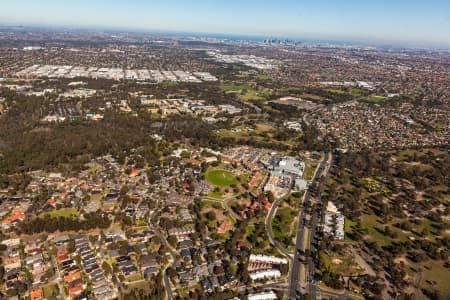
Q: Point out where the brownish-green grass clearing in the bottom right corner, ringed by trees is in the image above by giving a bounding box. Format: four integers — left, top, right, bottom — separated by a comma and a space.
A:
420, 261, 450, 299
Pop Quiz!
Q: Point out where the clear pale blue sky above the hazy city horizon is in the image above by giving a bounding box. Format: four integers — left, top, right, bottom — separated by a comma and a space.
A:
0, 0, 450, 48
